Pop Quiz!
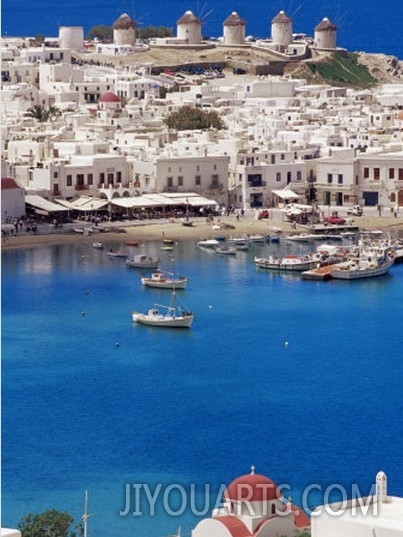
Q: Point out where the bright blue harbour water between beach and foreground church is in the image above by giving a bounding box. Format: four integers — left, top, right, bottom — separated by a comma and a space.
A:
2, 239, 403, 537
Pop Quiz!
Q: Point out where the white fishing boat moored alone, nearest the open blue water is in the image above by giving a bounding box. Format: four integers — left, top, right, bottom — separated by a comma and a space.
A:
132, 292, 194, 328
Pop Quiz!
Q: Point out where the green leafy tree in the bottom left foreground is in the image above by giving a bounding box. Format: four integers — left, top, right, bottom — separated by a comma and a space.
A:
18, 509, 83, 537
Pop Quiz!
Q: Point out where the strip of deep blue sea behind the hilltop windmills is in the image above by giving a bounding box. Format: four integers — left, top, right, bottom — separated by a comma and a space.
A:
1, 0, 403, 59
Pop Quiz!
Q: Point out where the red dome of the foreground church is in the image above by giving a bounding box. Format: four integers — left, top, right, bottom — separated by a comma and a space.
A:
224, 471, 282, 502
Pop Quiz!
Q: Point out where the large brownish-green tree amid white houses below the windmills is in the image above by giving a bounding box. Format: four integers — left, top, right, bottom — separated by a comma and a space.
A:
164, 105, 224, 131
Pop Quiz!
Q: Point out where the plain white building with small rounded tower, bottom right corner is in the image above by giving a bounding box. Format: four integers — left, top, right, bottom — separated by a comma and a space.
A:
311, 472, 403, 537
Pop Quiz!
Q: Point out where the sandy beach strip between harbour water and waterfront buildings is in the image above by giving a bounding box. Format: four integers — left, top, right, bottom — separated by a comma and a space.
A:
2, 210, 403, 251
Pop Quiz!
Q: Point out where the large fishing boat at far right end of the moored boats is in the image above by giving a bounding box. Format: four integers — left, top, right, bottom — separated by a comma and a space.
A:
331, 246, 396, 280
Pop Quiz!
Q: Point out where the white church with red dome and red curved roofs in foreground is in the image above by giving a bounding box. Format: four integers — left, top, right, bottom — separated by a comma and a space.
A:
192, 466, 309, 537
